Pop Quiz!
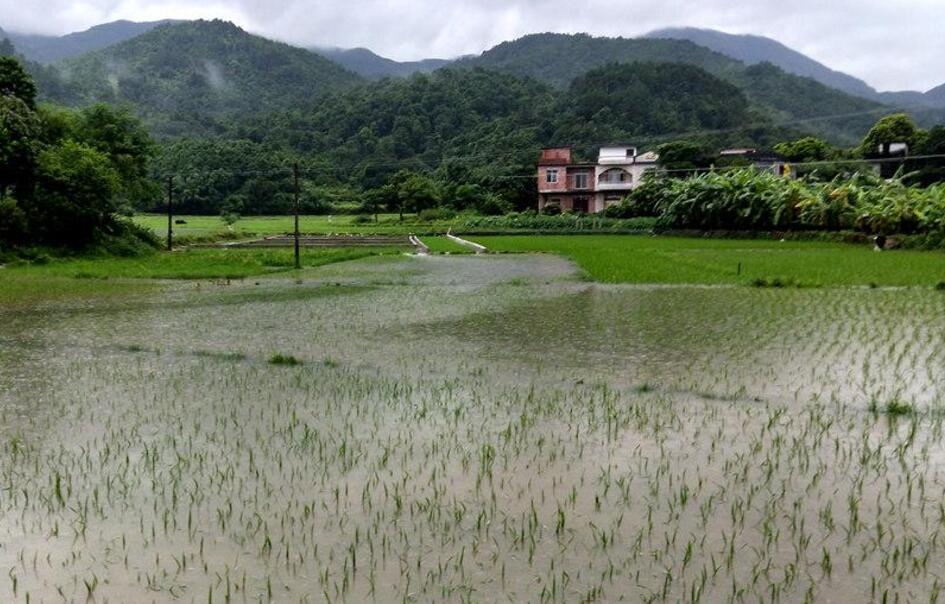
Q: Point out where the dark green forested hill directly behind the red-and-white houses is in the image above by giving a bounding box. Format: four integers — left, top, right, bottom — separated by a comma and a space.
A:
156, 64, 796, 212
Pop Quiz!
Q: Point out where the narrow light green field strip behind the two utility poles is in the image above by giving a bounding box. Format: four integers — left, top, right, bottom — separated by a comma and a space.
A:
133, 214, 448, 239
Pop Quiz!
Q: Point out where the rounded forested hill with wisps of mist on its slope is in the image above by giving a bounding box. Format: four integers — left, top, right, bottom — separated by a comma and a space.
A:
53, 21, 362, 135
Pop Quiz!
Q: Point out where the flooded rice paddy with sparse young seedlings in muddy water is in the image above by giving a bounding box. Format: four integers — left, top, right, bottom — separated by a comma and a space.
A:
0, 256, 945, 602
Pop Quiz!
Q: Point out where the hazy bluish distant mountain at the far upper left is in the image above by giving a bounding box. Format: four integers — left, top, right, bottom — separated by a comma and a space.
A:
0, 20, 172, 64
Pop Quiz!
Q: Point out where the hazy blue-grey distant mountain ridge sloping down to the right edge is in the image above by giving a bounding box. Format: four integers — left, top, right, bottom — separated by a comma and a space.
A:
644, 27, 945, 107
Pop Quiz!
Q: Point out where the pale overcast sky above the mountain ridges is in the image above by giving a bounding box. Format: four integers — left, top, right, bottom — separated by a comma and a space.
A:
0, 0, 945, 90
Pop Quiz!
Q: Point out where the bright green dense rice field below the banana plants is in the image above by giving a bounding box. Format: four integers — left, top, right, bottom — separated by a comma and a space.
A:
472, 235, 945, 287
